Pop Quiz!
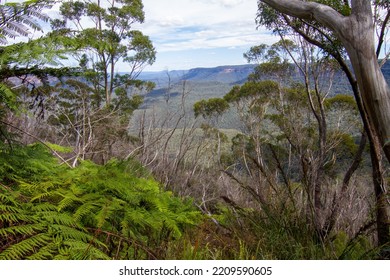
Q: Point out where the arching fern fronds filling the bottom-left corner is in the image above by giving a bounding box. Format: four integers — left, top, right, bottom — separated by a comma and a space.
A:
0, 190, 105, 259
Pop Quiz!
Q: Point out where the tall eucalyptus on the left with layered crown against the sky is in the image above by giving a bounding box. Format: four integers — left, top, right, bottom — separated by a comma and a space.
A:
41, 0, 156, 165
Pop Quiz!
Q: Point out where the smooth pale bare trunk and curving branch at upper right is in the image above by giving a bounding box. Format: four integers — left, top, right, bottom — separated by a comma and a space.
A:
261, 0, 390, 162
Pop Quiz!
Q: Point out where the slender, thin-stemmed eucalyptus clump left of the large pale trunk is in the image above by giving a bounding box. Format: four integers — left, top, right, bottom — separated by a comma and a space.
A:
224, 37, 362, 241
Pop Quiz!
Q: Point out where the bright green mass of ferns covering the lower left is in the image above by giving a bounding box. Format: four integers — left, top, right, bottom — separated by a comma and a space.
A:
0, 144, 200, 259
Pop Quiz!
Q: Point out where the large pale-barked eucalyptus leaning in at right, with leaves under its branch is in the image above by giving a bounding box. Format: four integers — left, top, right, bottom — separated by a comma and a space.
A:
259, 0, 390, 156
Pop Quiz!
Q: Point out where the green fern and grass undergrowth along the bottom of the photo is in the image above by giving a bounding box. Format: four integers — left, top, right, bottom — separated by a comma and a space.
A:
0, 144, 376, 260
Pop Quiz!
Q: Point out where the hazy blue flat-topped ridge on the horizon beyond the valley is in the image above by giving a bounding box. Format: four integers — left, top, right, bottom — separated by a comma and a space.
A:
139, 63, 390, 128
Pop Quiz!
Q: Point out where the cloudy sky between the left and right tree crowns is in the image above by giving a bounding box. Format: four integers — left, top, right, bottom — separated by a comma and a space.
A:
138, 0, 277, 71
